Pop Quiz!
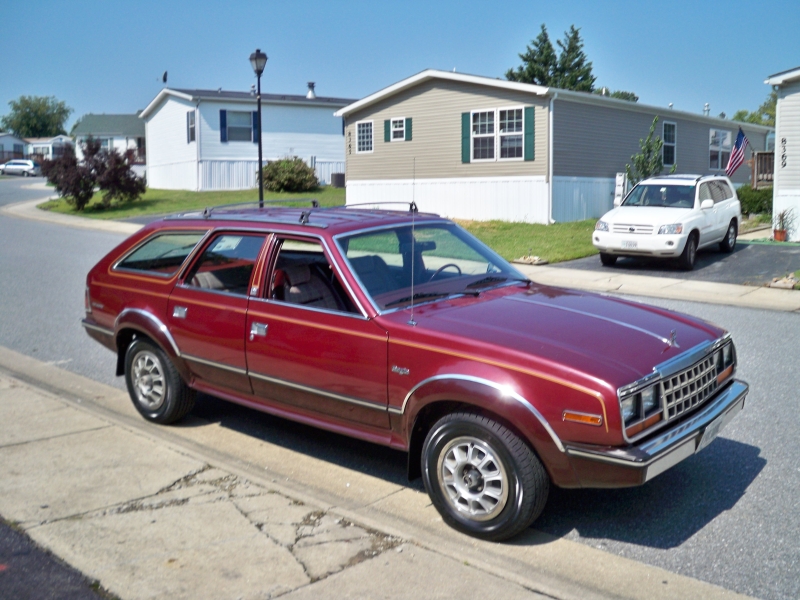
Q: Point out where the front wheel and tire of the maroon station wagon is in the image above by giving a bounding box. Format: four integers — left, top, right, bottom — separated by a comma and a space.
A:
422, 412, 550, 541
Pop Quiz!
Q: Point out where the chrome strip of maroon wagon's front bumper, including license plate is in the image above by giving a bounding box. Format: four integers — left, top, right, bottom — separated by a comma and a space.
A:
564, 380, 750, 481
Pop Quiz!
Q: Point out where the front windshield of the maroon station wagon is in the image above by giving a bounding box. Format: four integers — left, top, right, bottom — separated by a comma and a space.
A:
337, 223, 527, 310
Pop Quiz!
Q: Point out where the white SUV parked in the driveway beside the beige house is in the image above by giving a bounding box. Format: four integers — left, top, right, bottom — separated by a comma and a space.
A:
592, 175, 742, 271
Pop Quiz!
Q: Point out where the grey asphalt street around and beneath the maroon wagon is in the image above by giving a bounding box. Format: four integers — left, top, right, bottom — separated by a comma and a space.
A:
0, 180, 800, 600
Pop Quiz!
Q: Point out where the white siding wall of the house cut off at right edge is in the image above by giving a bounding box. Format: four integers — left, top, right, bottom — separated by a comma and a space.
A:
772, 83, 800, 242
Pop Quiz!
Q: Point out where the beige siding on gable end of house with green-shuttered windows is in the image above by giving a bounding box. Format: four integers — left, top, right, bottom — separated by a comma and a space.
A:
345, 81, 548, 181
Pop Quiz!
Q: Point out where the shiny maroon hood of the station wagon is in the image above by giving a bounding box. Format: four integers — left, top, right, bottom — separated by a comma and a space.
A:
390, 284, 724, 387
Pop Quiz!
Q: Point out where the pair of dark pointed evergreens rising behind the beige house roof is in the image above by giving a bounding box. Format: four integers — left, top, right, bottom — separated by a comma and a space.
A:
506, 23, 596, 92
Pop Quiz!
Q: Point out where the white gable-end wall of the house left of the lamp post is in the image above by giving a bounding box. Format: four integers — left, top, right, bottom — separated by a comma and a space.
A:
145, 96, 197, 190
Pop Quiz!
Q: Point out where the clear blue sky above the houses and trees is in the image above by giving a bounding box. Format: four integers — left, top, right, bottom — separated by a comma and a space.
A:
0, 0, 800, 129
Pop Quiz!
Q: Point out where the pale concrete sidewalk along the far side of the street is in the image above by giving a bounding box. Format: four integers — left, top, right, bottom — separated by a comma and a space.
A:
0, 200, 800, 312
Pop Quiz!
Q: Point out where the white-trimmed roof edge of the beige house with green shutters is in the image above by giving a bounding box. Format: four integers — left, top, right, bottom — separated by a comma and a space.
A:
334, 69, 774, 131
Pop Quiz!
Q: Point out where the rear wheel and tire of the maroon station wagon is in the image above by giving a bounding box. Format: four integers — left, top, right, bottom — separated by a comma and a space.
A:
125, 339, 196, 425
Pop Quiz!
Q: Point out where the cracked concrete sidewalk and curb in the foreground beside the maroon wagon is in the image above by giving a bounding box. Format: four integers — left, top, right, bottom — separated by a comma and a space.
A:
0, 347, 756, 600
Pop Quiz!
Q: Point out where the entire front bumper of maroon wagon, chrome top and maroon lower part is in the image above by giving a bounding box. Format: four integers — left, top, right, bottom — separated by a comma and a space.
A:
564, 380, 749, 488
